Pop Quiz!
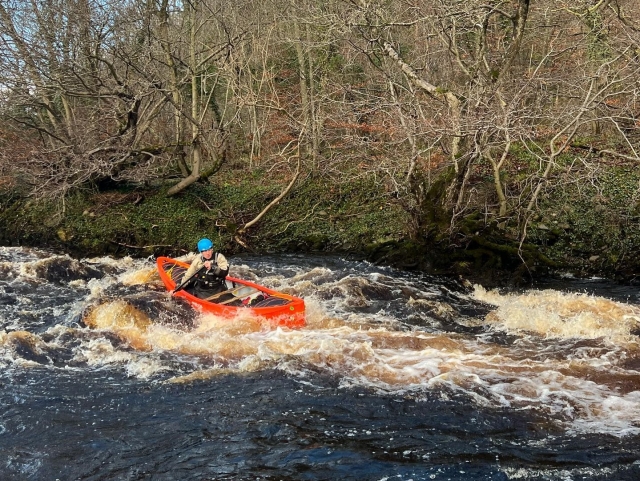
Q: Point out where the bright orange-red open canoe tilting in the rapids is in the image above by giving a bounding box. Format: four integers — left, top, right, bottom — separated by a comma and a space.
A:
156, 257, 305, 328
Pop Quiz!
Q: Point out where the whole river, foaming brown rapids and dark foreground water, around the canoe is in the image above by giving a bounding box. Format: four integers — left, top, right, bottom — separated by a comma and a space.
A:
0, 248, 640, 481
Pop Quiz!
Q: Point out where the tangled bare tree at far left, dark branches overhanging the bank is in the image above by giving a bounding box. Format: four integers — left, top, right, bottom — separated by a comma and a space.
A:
0, 0, 175, 196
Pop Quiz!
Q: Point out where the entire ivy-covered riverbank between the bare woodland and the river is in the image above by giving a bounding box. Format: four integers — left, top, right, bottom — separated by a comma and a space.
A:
0, 164, 640, 285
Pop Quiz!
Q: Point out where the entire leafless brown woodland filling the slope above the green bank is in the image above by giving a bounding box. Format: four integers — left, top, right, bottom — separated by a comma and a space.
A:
0, 0, 640, 251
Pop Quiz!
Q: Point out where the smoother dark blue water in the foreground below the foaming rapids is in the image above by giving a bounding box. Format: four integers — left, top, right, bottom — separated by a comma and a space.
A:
0, 371, 640, 481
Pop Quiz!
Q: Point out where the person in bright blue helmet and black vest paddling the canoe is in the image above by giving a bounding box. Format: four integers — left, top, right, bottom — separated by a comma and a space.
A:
182, 238, 229, 299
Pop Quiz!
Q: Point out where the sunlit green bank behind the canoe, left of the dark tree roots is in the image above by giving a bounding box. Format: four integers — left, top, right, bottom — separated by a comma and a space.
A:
0, 171, 408, 255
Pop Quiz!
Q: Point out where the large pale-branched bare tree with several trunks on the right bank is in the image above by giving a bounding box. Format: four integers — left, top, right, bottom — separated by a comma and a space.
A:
336, 0, 637, 242
